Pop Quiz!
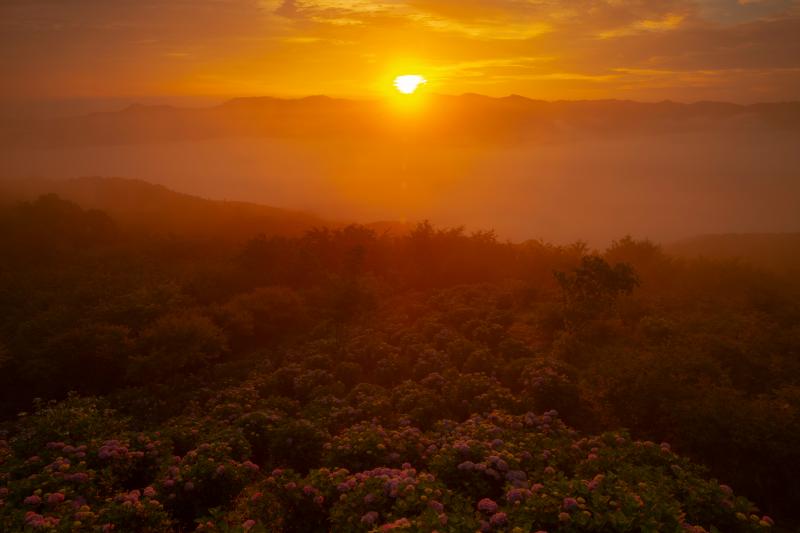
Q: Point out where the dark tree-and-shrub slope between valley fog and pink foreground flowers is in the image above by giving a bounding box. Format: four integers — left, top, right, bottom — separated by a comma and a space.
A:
0, 193, 800, 530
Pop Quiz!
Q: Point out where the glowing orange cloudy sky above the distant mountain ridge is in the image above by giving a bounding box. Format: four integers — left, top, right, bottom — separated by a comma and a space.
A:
0, 0, 800, 102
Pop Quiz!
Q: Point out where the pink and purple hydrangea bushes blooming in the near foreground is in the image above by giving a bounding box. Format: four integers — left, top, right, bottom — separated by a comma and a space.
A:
0, 392, 773, 532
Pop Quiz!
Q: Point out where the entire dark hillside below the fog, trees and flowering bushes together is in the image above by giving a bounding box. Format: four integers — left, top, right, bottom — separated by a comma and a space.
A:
0, 196, 800, 532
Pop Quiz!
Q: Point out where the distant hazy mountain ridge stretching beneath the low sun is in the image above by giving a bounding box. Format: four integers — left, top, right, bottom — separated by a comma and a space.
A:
0, 94, 800, 147
